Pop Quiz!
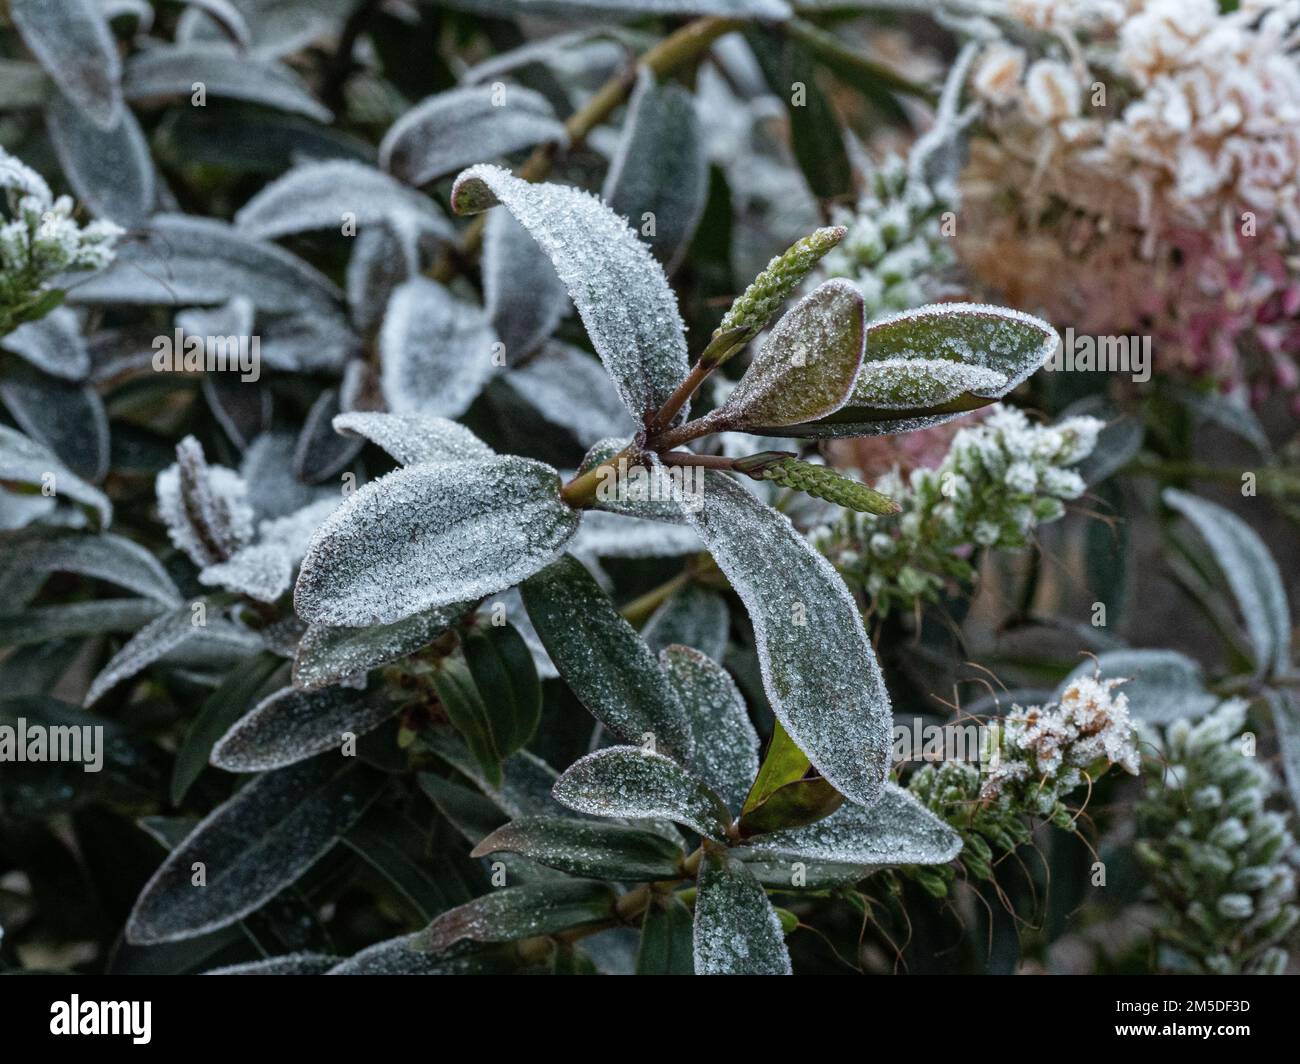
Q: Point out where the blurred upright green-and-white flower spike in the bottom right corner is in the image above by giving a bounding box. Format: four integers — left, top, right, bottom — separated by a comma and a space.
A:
1136, 698, 1300, 974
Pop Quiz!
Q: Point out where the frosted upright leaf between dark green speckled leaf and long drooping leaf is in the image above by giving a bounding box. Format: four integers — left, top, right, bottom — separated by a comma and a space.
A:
659, 645, 758, 812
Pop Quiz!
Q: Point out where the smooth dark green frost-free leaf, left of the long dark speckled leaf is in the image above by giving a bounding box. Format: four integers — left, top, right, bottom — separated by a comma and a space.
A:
460, 624, 542, 758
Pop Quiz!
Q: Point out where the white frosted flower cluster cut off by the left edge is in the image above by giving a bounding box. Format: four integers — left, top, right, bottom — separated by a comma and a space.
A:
0, 148, 122, 333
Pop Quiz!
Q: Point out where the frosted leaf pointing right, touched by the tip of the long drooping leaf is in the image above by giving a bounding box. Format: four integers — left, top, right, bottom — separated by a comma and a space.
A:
745, 783, 962, 868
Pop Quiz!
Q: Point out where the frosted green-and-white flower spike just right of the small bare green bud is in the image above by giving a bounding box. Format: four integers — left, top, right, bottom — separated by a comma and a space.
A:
813, 406, 1102, 613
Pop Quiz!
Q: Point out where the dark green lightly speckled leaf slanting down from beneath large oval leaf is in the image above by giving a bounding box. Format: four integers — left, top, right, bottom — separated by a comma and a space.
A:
523, 557, 693, 757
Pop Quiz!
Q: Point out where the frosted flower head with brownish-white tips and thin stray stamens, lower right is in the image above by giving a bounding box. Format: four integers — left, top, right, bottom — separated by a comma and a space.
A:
980, 676, 1139, 817
